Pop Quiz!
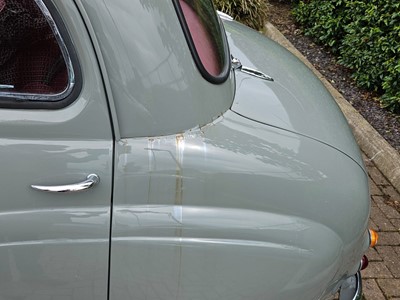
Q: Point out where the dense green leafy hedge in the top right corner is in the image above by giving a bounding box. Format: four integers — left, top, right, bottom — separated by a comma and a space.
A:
294, 0, 400, 112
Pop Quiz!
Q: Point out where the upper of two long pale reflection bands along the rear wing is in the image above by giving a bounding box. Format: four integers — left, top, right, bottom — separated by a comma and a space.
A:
115, 205, 310, 231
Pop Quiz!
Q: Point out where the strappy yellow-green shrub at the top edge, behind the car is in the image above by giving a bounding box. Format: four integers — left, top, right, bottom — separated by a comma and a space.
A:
214, 0, 268, 30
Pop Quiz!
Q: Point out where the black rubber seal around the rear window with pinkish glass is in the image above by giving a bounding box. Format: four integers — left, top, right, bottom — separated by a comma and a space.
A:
172, 0, 231, 84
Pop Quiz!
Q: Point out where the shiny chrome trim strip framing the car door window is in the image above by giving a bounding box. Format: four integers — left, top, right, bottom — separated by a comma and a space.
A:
0, 0, 76, 102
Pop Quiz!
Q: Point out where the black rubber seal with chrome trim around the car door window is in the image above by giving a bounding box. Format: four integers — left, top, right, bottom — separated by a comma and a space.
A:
0, 0, 82, 110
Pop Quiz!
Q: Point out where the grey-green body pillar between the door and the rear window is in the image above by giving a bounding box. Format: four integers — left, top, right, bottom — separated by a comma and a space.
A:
77, 0, 234, 137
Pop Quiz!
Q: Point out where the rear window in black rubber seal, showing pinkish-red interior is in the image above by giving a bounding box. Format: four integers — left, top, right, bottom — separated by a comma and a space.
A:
174, 0, 230, 83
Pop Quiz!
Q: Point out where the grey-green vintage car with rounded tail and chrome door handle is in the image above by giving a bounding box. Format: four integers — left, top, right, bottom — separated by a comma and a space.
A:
0, 0, 376, 300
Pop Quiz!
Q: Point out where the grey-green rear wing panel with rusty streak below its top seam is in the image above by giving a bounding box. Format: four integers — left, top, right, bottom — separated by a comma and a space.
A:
110, 111, 369, 299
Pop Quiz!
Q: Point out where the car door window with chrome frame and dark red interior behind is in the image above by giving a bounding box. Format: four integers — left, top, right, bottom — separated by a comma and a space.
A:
0, 0, 75, 101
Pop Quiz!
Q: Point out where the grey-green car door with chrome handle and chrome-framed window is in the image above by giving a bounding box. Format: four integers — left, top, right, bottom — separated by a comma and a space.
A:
0, 0, 113, 300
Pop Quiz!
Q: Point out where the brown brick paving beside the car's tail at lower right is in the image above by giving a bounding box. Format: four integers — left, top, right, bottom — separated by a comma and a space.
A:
362, 155, 400, 300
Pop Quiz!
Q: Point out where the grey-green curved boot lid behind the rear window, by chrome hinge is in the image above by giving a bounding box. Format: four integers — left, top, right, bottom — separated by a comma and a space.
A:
225, 21, 363, 170
